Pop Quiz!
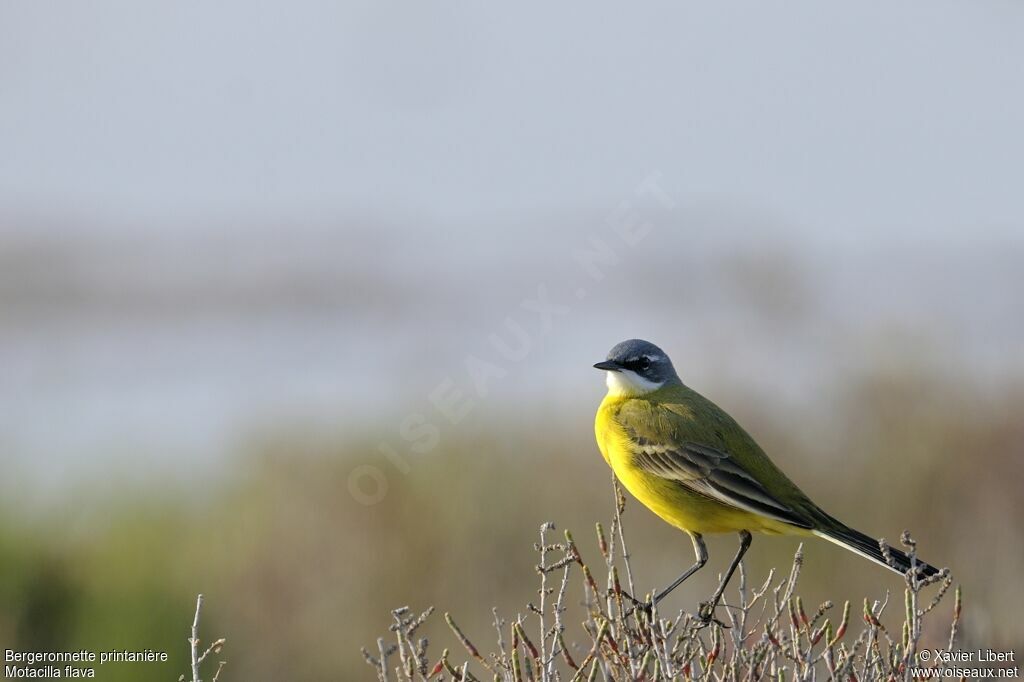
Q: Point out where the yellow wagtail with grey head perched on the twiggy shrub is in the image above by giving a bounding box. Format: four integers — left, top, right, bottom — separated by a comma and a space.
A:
594, 339, 939, 625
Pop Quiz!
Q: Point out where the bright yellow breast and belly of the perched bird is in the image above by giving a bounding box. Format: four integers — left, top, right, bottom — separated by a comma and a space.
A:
594, 400, 800, 535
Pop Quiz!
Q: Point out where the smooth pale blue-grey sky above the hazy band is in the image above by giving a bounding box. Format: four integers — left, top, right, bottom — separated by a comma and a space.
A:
0, 0, 1024, 239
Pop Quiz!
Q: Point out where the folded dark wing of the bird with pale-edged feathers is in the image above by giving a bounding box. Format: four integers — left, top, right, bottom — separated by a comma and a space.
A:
631, 434, 811, 528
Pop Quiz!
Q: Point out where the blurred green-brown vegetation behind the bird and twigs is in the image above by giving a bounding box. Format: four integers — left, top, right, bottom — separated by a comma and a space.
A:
0, 357, 1024, 680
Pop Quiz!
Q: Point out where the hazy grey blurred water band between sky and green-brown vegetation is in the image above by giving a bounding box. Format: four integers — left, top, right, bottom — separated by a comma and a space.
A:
0, 220, 1024, 492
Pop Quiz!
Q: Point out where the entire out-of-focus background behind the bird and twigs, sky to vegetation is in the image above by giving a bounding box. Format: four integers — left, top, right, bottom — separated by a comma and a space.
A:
0, 0, 1024, 680
